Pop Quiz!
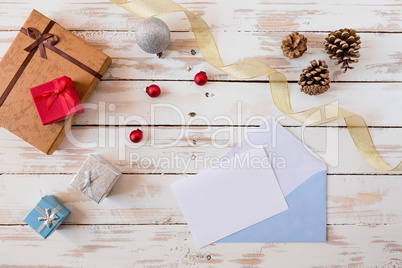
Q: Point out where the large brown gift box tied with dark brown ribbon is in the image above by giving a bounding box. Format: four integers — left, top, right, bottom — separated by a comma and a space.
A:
0, 10, 111, 154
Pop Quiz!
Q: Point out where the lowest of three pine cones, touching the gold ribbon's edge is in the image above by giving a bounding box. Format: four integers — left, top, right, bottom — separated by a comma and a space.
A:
298, 60, 330, 95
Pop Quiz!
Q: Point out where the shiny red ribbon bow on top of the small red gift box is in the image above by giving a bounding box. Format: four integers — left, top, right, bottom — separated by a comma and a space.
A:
34, 77, 75, 114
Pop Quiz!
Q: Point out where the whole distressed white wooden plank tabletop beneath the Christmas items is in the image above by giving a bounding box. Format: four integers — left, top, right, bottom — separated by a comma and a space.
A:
0, 0, 402, 267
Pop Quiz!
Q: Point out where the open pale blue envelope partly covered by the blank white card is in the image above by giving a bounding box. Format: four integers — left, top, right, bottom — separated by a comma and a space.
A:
217, 117, 327, 243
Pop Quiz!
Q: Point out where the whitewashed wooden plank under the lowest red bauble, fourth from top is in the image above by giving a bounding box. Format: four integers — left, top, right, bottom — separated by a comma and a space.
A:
0, 125, 402, 174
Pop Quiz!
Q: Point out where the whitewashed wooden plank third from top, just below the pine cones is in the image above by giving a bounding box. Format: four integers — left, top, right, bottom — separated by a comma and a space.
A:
75, 81, 402, 126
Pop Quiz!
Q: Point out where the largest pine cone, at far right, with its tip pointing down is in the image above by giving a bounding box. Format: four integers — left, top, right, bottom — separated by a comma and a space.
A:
325, 28, 361, 72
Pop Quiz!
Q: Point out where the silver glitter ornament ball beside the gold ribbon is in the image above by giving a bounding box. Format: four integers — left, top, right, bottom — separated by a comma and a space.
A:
135, 18, 170, 54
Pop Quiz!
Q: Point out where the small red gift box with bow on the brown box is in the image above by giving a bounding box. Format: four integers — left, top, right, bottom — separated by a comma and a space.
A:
29, 76, 84, 125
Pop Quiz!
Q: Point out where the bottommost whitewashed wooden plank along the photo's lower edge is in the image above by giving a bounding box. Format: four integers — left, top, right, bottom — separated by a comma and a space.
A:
0, 225, 402, 267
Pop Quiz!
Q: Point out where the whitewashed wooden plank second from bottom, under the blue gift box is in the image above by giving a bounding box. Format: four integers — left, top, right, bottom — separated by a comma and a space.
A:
0, 175, 402, 225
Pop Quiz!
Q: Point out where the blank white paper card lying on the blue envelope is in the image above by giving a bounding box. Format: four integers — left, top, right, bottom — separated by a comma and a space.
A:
172, 148, 288, 248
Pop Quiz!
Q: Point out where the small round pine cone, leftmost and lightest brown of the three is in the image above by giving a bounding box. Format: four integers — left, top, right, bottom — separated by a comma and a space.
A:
281, 32, 307, 59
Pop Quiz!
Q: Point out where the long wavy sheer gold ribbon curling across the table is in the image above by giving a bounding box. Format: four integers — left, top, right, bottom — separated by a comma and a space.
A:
111, 0, 402, 171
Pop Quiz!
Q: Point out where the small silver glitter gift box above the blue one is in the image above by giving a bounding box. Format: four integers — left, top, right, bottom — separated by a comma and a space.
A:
70, 155, 121, 203
